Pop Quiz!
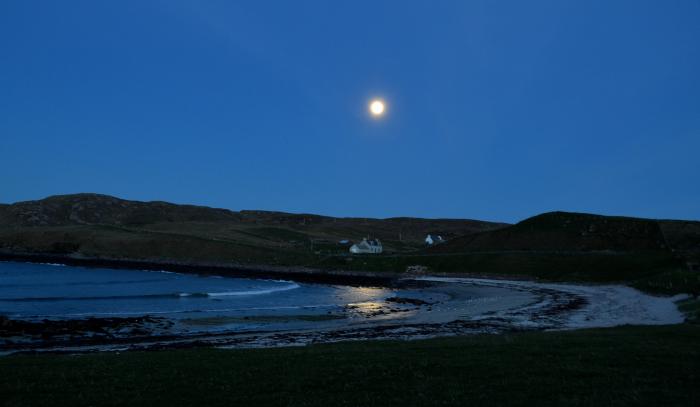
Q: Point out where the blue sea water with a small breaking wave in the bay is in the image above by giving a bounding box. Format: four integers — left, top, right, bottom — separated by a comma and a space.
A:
0, 262, 394, 319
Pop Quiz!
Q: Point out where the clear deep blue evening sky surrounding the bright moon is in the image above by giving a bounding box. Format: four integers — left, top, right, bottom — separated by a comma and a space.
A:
0, 0, 700, 221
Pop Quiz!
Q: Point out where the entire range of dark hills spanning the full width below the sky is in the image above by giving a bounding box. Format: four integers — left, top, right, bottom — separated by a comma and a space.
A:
0, 194, 700, 293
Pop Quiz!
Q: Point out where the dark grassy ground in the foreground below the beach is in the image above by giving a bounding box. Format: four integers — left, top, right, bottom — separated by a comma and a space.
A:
0, 324, 700, 406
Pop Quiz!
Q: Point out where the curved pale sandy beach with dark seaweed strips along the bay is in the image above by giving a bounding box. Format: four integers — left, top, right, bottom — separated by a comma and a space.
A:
0, 258, 684, 355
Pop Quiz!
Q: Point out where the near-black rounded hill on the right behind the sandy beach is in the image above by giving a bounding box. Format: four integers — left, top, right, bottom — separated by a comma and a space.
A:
322, 212, 700, 293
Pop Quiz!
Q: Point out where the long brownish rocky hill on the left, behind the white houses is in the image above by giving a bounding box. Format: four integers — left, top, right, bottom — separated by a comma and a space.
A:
0, 194, 505, 265
